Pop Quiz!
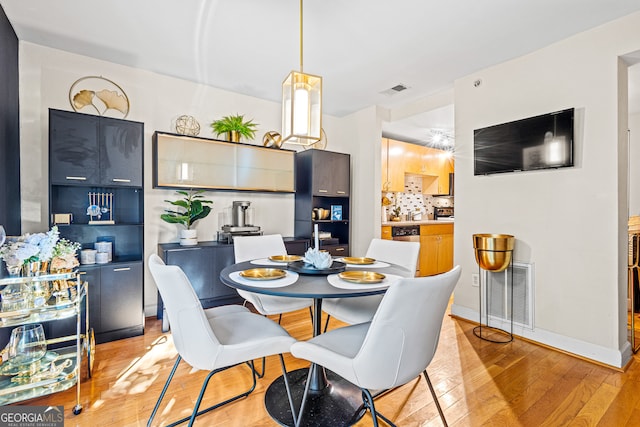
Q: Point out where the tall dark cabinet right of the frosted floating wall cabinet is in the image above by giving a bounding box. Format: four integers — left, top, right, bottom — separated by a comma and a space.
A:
294, 149, 351, 256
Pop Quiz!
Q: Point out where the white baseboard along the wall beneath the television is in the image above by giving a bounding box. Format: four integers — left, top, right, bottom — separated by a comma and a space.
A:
451, 304, 633, 370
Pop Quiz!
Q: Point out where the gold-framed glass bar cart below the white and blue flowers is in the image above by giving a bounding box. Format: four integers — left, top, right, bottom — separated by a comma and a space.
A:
0, 272, 95, 415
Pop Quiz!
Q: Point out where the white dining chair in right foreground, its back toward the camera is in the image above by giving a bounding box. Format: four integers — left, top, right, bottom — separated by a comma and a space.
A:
291, 266, 461, 426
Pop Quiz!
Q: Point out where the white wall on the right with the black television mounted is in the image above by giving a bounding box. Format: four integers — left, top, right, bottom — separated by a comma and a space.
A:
453, 13, 640, 366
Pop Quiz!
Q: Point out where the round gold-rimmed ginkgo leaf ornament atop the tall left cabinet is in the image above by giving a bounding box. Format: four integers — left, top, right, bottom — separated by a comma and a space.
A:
69, 76, 129, 119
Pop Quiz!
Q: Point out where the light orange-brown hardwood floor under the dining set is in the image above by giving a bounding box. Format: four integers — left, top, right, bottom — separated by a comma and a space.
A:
12, 310, 640, 427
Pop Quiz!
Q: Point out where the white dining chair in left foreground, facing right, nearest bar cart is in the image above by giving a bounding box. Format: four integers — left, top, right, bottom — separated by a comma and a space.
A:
147, 254, 296, 426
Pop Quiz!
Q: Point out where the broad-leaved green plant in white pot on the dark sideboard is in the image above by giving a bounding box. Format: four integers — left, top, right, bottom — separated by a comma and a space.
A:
160, 190, 213, 246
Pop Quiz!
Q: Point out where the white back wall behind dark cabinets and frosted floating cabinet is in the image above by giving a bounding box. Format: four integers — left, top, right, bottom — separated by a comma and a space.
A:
20, 42, 364, 315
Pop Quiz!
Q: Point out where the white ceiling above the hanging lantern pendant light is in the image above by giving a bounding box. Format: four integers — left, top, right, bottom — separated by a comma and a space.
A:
0, 0, 640, 145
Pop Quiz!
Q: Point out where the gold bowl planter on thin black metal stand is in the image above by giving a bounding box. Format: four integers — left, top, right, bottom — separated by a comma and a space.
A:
473, 234, 515, 344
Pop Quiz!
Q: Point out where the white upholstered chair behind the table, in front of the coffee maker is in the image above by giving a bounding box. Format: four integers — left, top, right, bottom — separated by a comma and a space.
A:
233, 234, 313, 322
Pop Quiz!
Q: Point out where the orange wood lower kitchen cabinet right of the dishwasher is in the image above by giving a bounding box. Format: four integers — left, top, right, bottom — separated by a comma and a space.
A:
420, 224, 453, 276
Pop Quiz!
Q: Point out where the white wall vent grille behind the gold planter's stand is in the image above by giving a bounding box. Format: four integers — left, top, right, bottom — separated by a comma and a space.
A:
481, 262, 534, 330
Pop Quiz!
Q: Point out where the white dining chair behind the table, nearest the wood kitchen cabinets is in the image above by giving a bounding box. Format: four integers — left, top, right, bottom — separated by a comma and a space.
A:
322, 239, 420, 331
